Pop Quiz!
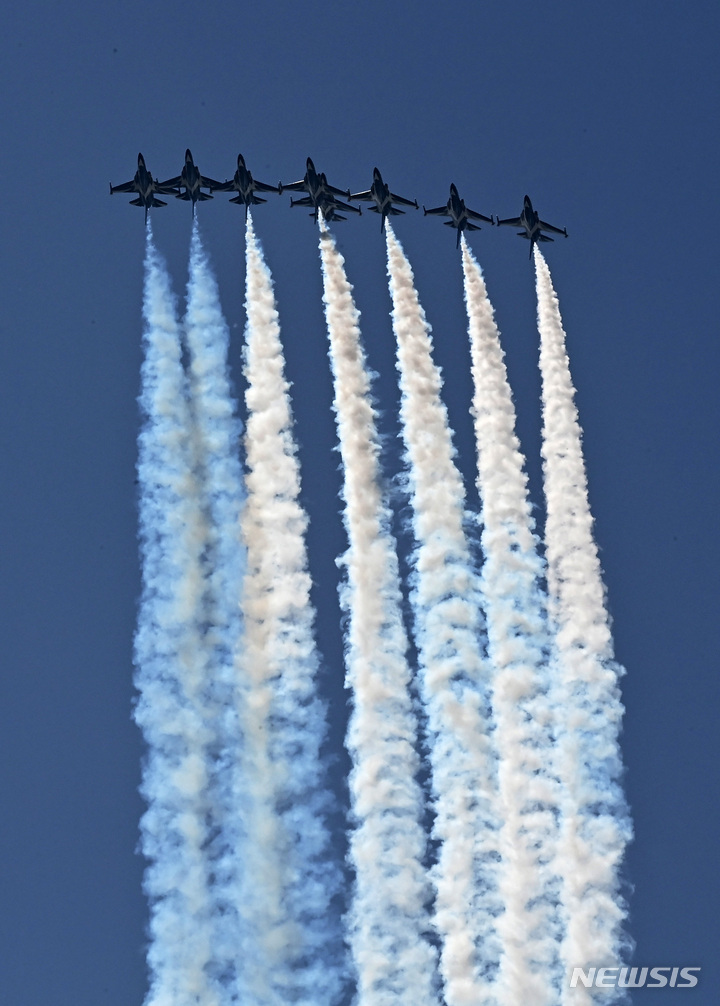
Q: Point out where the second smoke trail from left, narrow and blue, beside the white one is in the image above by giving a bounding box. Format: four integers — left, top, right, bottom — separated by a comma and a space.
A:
184, 221, 247, 996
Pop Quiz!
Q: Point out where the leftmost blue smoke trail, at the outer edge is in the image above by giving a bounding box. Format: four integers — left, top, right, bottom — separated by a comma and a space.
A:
135, 226, 220, 1006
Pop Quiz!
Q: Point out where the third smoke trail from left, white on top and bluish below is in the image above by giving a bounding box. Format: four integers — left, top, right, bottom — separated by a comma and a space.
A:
235, 213, 347, 1006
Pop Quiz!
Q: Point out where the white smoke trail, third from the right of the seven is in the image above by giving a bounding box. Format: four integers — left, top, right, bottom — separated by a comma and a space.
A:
385, 222, 499, 1006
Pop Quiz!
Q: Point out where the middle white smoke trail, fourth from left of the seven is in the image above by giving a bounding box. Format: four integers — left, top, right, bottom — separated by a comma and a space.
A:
320, 220, 438, 1006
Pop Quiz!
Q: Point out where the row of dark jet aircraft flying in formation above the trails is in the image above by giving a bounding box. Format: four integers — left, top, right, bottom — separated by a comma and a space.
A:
110, 150, 567, 258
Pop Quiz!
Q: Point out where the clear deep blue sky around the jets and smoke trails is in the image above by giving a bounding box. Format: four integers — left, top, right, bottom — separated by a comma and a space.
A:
0, 0, 720, 1006
